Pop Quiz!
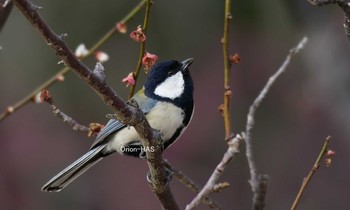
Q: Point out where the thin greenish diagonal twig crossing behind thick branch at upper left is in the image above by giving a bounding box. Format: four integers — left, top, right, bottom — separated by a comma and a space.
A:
0, 0, 147, 122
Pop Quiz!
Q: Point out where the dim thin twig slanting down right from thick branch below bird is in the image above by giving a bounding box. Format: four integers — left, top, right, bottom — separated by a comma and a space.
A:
164, 160, 221, 210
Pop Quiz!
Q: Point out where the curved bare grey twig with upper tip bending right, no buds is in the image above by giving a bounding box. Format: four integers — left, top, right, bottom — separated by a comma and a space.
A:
243, 37, 308, 209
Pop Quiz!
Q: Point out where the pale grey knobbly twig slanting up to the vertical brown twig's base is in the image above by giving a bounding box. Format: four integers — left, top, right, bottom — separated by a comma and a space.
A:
186, 135, 242, 210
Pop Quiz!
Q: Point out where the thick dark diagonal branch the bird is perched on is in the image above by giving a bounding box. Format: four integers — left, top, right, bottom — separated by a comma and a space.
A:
13, 0, 178, 209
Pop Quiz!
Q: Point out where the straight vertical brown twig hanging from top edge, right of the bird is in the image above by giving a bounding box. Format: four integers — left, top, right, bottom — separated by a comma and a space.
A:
222, 0, 232, 141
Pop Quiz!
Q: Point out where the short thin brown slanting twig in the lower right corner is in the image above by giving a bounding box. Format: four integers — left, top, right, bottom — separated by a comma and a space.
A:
291, 136, 332, 210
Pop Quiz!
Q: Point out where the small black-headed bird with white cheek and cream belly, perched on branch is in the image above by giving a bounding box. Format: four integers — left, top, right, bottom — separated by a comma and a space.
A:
41, 58, 194, 192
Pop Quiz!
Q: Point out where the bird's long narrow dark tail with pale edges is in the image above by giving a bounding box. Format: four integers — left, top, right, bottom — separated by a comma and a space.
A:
41, 145, 106, 192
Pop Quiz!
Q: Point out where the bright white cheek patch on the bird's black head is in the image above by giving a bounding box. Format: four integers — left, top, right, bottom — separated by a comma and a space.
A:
154, 71, 185, 99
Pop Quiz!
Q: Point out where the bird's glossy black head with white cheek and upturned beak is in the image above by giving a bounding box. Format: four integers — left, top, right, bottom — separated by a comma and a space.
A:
144, 58, 193, 107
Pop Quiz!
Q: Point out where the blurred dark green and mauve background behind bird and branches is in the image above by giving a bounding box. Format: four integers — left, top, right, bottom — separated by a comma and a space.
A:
0, 0, 350, 210
